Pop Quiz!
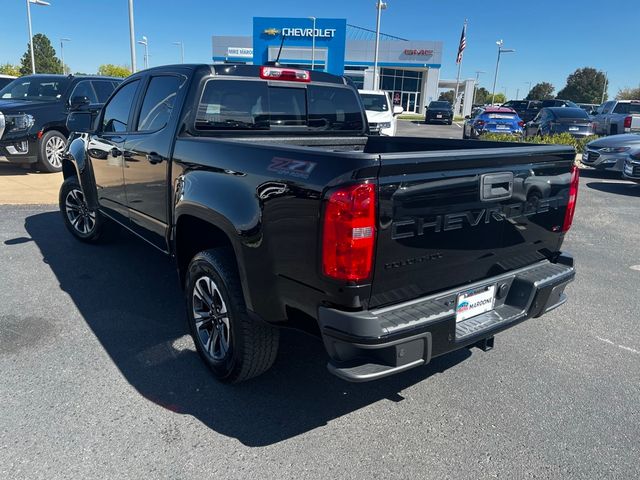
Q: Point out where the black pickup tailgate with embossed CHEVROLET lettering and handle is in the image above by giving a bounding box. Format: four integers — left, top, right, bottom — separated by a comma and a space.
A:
370, 146, 575, 308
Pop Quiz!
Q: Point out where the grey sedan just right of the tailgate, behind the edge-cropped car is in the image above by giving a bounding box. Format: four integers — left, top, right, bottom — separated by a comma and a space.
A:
582, 133, 640, 172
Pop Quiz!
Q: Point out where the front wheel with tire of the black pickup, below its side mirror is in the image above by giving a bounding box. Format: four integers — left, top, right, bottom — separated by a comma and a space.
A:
58, 177, 105, 243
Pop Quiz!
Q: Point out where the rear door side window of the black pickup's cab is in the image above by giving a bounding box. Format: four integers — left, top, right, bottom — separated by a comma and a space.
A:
136, 75, 184, 132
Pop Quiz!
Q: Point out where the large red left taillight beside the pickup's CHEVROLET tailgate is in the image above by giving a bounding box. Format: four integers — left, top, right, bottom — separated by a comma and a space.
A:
322, 183, 376, 282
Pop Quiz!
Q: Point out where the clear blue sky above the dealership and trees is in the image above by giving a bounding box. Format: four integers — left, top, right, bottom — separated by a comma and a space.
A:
0, 0, 640, 98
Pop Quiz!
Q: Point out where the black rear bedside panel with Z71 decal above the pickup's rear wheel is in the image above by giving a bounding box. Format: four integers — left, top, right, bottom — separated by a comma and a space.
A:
172, 138, 379, 322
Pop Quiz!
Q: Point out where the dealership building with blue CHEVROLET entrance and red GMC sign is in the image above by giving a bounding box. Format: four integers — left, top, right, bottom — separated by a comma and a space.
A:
212, 17, 473, 113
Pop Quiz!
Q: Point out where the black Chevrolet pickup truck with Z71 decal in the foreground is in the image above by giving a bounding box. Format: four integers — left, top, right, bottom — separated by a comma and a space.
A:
60, 65, 578, 382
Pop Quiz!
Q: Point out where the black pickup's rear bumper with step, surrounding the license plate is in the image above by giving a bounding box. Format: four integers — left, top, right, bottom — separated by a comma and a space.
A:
318, 254, 575, 382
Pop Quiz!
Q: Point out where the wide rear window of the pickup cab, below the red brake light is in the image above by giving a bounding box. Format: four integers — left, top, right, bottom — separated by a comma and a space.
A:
195, 78, 365, 133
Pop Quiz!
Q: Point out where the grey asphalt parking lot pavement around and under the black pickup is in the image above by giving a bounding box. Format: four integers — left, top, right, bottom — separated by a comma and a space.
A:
0, 122, 640, 479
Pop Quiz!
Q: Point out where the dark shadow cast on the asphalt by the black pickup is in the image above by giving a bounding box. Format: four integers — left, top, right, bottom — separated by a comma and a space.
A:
22, 212, 471, 446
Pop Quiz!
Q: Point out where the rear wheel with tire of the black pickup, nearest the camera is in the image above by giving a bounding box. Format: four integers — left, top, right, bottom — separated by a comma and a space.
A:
185, 248, 280, 383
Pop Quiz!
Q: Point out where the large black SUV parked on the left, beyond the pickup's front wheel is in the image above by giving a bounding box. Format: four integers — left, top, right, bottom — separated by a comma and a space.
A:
0, 75, 122, 172
